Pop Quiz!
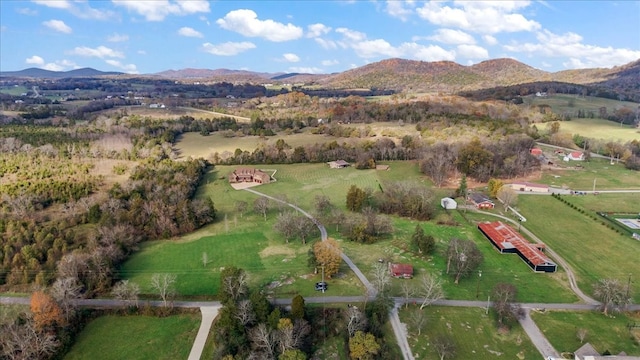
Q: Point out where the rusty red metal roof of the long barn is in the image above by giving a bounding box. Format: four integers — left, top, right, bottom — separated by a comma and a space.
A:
478, 221, 555, 266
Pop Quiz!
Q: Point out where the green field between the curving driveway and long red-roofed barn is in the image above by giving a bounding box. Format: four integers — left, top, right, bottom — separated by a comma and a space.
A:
342, 212, 578, 303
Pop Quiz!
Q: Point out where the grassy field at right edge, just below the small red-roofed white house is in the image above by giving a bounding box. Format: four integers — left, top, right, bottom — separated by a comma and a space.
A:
536, 158, 640, 191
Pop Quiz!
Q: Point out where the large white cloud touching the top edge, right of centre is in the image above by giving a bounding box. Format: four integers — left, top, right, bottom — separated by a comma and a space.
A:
416, 1, 541, 34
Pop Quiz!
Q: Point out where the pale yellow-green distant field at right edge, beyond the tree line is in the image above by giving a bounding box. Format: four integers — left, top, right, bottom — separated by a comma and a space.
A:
560, 118, 640, 142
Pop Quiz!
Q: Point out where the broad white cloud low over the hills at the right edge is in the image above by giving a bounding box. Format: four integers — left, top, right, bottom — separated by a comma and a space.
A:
504, 30, 640, 69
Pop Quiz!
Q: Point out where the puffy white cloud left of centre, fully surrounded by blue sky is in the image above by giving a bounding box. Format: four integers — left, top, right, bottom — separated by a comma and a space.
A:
216, 9, 302, 42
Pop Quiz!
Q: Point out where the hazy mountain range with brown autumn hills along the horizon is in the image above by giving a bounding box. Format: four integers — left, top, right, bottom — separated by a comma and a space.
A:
0, 58, 640, 94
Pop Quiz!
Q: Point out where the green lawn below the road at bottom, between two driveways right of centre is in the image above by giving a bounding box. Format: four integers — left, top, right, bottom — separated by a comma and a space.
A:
400, 306, 541, 360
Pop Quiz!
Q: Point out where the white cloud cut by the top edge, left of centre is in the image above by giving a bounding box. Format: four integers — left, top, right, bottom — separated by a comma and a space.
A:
111, 0, 210, 21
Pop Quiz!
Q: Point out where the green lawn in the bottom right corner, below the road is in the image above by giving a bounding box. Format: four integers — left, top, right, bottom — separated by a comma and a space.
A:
531, 311, 640, 356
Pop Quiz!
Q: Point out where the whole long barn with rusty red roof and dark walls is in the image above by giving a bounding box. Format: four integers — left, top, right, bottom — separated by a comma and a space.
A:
478, 221, 558, 272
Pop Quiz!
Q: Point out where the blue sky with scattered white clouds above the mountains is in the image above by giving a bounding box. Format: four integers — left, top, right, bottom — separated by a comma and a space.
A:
0, 0, 640, 74
